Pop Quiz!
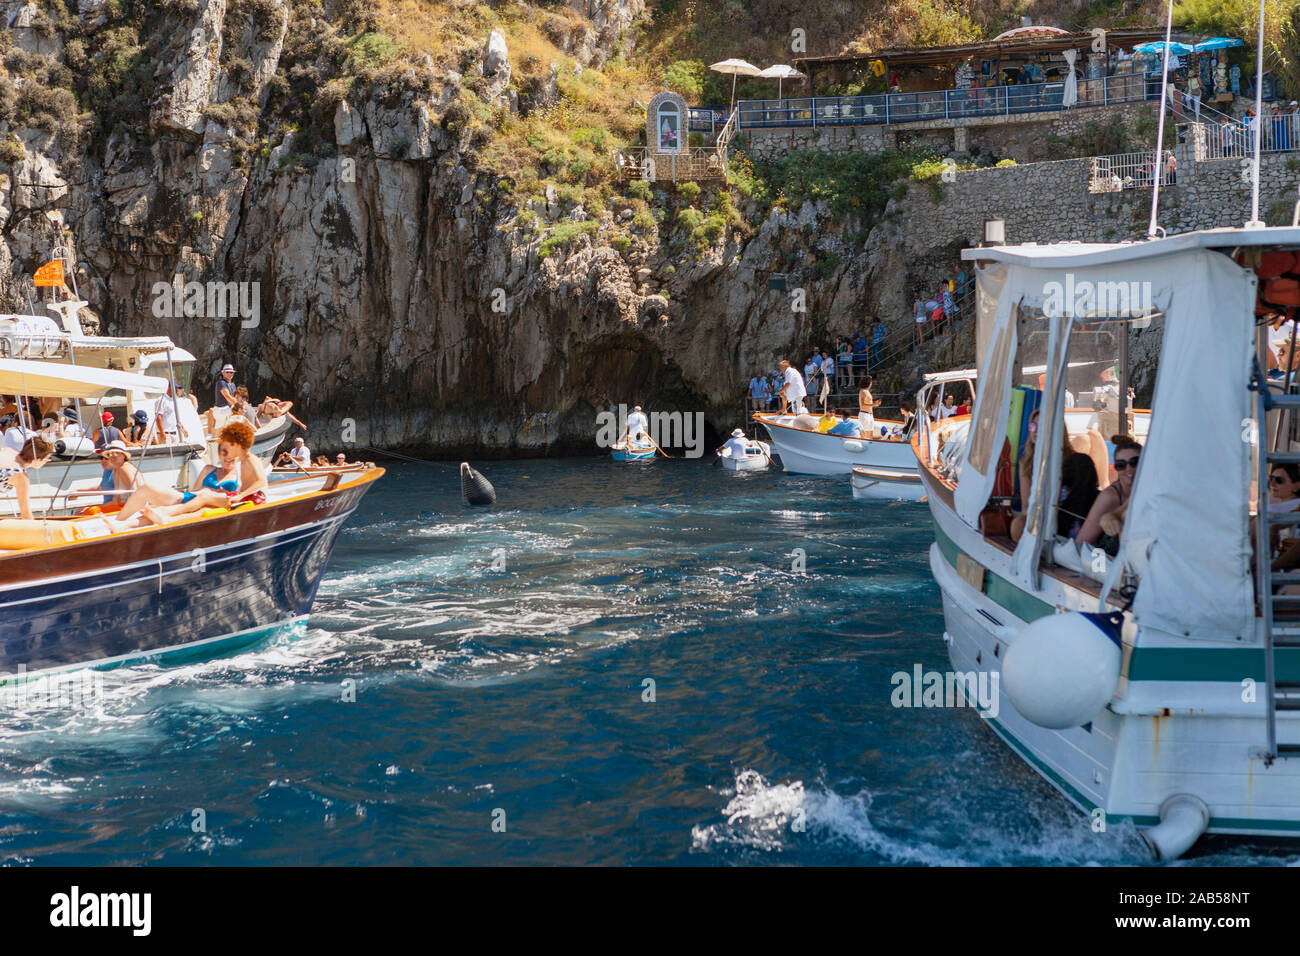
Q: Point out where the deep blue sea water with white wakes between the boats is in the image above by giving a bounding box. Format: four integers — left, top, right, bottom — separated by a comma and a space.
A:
0, 459, 1300, 865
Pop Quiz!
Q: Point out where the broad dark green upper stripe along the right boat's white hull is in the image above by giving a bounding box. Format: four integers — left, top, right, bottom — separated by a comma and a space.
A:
935, 522, 1300, 684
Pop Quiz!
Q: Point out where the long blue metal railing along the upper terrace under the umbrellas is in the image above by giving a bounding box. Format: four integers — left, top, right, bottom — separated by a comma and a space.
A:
736, 73, 1160, 130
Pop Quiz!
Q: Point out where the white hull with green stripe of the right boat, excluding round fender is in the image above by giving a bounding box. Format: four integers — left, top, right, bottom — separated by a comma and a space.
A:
930, 476, 1300, 836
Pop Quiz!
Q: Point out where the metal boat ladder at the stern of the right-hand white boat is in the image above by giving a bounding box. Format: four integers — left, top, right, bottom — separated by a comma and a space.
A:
1252, 369, 1300, 765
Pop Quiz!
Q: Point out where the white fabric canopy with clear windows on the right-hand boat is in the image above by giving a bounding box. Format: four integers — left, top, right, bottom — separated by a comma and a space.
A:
954, 243, 1258, 640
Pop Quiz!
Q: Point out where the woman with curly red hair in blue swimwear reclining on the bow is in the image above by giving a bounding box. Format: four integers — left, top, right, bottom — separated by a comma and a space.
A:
108, 421, 267, 531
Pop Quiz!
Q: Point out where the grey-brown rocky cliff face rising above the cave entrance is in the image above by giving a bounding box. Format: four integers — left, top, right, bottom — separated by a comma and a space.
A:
0, 0, 1170, 455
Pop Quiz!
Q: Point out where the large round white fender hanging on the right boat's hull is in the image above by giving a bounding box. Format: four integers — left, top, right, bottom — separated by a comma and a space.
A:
1002, 611, 1121, 730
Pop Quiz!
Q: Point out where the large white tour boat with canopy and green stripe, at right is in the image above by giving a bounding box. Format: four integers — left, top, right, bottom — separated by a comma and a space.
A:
913, 222, 1300, 858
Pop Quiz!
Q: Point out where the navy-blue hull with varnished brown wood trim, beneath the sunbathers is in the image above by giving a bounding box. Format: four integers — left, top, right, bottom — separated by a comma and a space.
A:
0, 468, 384, 680
